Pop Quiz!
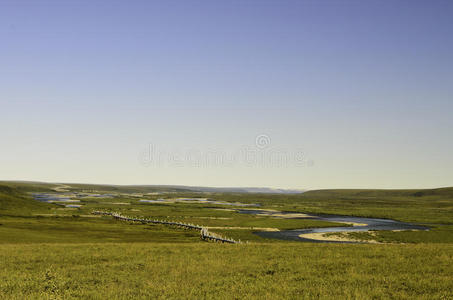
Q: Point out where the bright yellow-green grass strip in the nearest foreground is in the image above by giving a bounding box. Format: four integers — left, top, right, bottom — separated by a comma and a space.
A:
0, 243, 453, 299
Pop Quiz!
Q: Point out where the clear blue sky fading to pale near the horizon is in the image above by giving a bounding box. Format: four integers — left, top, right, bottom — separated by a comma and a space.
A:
0, 0, 453, 189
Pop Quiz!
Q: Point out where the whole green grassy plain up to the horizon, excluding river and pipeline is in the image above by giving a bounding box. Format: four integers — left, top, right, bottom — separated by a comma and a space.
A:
0, 182, 453, 299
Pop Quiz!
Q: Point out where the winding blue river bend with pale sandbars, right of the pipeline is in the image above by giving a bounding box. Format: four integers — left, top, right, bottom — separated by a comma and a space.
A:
238, 209, 429, 243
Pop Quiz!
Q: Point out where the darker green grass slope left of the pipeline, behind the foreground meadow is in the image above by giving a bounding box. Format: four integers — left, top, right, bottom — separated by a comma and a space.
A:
0, 216, 200, 244
